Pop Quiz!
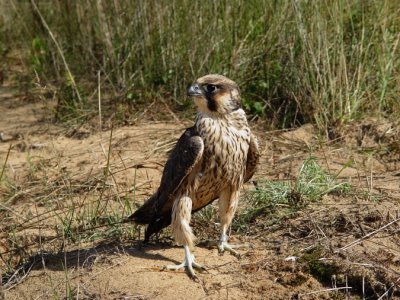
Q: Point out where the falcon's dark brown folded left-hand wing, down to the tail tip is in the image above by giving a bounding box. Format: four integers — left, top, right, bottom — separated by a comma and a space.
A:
128, 127, 204, 240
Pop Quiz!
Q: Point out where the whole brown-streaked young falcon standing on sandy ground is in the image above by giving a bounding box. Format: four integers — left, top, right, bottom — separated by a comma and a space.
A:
129, 74, 259, 278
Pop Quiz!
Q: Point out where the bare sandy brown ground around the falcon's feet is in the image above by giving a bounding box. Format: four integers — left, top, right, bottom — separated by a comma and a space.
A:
0, 78, 400, 299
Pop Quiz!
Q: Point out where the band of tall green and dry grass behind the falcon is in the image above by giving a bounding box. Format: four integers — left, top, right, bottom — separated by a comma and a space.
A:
0, 0, 400, 129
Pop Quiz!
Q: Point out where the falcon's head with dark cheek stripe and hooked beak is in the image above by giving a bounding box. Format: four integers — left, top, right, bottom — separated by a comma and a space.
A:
188, 74, 241, 114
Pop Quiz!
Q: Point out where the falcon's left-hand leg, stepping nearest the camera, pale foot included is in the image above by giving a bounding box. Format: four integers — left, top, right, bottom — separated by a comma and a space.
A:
165, 196, 204, 279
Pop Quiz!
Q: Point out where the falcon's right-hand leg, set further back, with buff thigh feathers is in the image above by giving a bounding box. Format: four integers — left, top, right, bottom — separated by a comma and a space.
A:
218, 189, 242, 257
